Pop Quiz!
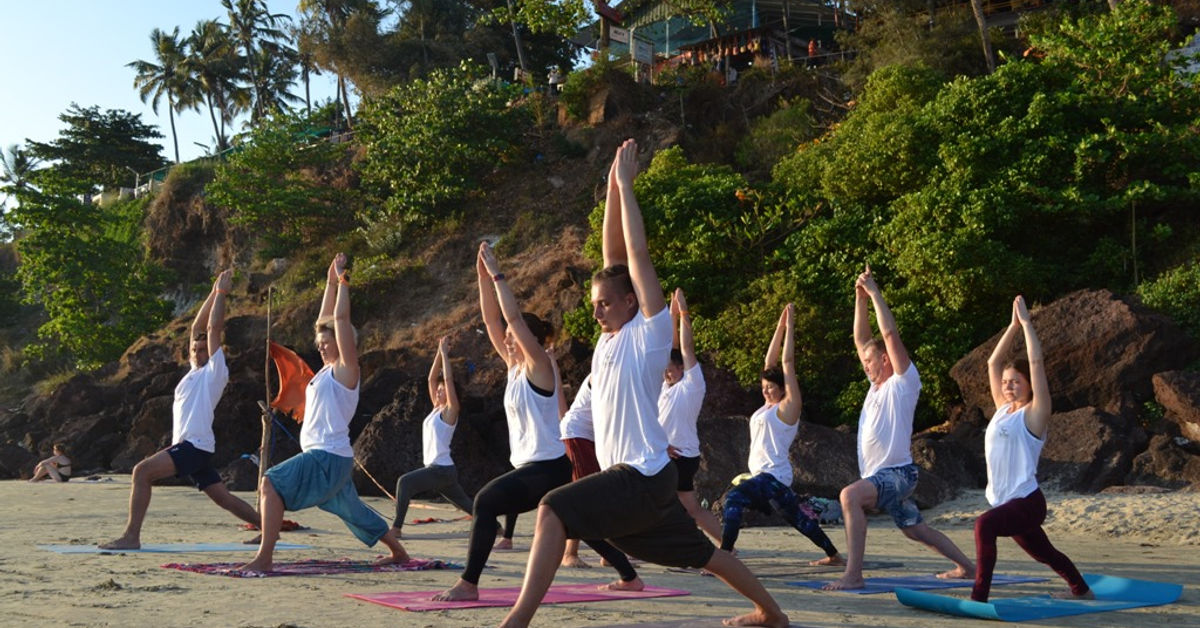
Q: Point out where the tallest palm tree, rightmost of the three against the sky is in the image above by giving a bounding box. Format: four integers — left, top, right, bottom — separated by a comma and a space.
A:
221, 0, 292, 124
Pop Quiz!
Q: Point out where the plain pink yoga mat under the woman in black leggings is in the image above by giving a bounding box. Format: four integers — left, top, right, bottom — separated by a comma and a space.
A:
346, 582, 691, 611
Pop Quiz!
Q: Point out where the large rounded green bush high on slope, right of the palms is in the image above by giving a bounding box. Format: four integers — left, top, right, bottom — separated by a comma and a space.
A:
358, 64, 527, 247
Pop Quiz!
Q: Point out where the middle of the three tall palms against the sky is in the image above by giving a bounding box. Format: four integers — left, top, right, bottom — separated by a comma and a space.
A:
186, 19, 246, 152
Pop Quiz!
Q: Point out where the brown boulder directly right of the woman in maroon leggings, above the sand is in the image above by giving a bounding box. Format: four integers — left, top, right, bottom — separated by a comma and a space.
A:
1038, 407, 1147, 492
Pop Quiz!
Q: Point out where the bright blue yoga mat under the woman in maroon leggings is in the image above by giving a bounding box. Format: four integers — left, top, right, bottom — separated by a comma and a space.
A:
896, 574, 1183, 622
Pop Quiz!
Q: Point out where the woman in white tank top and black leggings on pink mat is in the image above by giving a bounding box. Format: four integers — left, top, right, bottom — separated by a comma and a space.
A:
433, 241, 643, 602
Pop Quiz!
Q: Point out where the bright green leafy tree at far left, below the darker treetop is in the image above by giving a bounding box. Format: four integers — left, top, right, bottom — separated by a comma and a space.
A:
13, 174, 170, 369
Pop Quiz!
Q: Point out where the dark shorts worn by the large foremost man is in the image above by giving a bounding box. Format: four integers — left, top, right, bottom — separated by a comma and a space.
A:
541, 465, 716, 568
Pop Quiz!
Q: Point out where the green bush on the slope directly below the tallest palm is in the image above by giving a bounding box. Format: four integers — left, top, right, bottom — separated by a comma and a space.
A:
206, 112, 355, 257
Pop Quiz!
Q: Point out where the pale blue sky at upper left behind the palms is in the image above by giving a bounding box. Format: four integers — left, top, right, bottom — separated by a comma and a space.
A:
0, 0, 336, 172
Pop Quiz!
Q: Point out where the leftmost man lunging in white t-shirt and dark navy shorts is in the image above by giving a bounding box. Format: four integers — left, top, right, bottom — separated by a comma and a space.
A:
100, 270, 258, 550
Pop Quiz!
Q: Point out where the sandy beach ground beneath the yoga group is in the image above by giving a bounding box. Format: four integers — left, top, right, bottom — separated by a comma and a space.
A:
0, 476, 1200, 627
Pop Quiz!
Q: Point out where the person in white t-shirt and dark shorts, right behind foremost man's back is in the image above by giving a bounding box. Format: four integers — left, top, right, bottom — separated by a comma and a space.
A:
659, 288, 721, 540
